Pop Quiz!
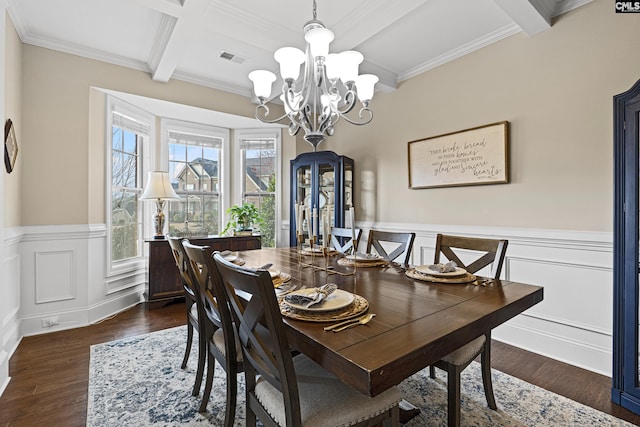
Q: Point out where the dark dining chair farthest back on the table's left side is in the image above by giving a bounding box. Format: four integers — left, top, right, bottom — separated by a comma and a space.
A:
167, 237, 207, 396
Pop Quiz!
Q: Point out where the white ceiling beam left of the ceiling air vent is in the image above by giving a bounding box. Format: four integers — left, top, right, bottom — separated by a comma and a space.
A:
148, 0, 212, 82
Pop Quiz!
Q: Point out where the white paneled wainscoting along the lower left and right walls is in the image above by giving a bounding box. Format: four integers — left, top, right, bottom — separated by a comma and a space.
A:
0, 223, 613, 392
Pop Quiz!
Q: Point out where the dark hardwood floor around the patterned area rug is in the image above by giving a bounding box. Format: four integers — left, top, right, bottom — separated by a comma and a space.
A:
0, 303, 640, 427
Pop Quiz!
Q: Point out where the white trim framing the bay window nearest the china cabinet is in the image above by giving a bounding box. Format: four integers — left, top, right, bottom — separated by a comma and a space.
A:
234, 129, 282, 247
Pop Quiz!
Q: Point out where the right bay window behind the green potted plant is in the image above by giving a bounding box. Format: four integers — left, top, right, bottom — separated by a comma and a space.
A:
237, 131, 280, 247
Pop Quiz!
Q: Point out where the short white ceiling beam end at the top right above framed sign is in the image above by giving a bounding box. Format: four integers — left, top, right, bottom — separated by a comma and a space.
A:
493, 0, 557, 36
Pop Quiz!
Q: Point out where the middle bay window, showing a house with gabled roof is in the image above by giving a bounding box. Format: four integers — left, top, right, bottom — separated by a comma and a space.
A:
163, 120, 228, 236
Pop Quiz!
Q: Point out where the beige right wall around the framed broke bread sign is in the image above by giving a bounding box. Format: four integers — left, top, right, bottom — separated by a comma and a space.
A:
320, 0, 640, 231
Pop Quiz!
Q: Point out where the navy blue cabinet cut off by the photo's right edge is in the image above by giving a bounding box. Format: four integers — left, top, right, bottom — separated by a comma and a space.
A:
611, 81, 640, 414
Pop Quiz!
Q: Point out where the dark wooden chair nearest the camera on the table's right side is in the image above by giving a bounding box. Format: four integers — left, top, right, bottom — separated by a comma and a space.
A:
429, 234, 509, 427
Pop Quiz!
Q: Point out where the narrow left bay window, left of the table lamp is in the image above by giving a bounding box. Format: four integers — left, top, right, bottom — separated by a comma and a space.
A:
106, 98, 151, 271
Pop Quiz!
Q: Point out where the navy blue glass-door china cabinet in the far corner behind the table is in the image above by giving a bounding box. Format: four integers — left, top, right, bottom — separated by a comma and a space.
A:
289, 151, 354, 246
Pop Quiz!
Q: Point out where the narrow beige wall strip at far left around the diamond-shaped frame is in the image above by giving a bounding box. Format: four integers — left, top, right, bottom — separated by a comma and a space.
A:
2, 13, 24, 228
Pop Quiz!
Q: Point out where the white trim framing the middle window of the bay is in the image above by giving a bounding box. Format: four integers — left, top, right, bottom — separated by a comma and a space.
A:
160, 119, 231, 236
